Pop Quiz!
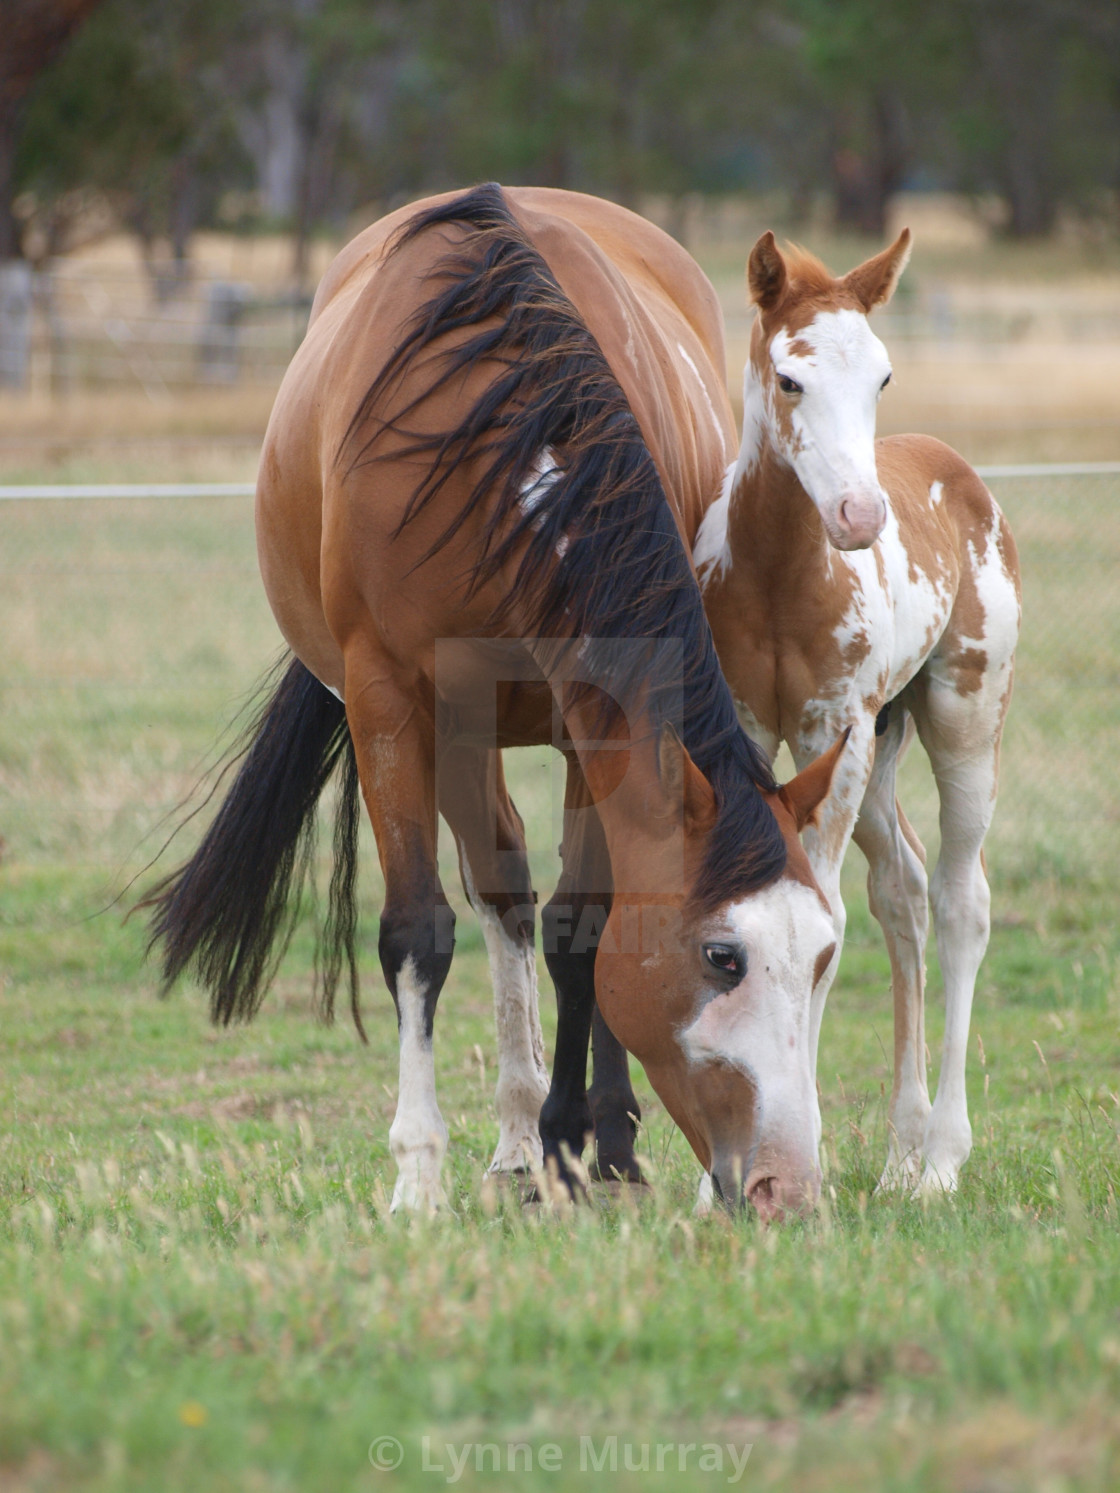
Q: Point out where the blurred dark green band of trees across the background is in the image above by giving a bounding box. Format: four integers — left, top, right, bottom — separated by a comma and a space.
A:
0, 0, 1120, 278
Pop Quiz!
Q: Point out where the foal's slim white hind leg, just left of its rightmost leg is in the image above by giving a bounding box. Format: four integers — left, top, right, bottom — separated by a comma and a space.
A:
853, 705, 930, 1187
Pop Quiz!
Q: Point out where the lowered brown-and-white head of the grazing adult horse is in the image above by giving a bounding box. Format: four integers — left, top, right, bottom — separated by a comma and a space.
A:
594, 730, 844, 1220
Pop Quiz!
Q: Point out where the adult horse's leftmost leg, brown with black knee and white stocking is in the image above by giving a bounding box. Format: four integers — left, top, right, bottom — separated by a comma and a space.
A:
346, 655, 455, 1212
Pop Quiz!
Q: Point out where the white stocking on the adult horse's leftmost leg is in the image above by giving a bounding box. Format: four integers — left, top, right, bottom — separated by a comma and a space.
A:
388, 956, 448, 1212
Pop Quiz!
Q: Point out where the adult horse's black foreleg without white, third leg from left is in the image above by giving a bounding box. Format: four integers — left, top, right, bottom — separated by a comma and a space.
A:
541, 754, 611, 1184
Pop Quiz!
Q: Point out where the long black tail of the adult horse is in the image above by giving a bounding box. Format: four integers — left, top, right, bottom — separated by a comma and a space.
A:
139, 658, 366, 1039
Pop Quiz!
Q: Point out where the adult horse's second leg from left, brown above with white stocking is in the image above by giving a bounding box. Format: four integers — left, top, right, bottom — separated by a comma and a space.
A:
439, 744, 548, 1172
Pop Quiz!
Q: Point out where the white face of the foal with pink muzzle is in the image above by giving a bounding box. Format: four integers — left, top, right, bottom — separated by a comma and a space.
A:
764, 309, 890, 549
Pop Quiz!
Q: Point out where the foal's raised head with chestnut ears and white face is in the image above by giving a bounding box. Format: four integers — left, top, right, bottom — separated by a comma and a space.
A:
744, 228, 909, 549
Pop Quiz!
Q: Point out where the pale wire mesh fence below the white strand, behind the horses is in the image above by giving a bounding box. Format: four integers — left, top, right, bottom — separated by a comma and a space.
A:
0, 464, 1120, 905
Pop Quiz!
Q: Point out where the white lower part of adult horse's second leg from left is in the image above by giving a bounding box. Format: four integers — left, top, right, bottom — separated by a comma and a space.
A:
461, 854, 548, 1172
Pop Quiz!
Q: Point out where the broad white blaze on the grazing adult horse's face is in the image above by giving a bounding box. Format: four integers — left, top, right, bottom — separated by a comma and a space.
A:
679, 878, 833, 1172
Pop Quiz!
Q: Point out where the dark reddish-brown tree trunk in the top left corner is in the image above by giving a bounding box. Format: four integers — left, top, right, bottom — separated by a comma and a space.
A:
0, 0, 102, 261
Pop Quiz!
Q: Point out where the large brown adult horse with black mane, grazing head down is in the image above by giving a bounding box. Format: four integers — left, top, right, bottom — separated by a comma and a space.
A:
149, 187, 839, 1215
